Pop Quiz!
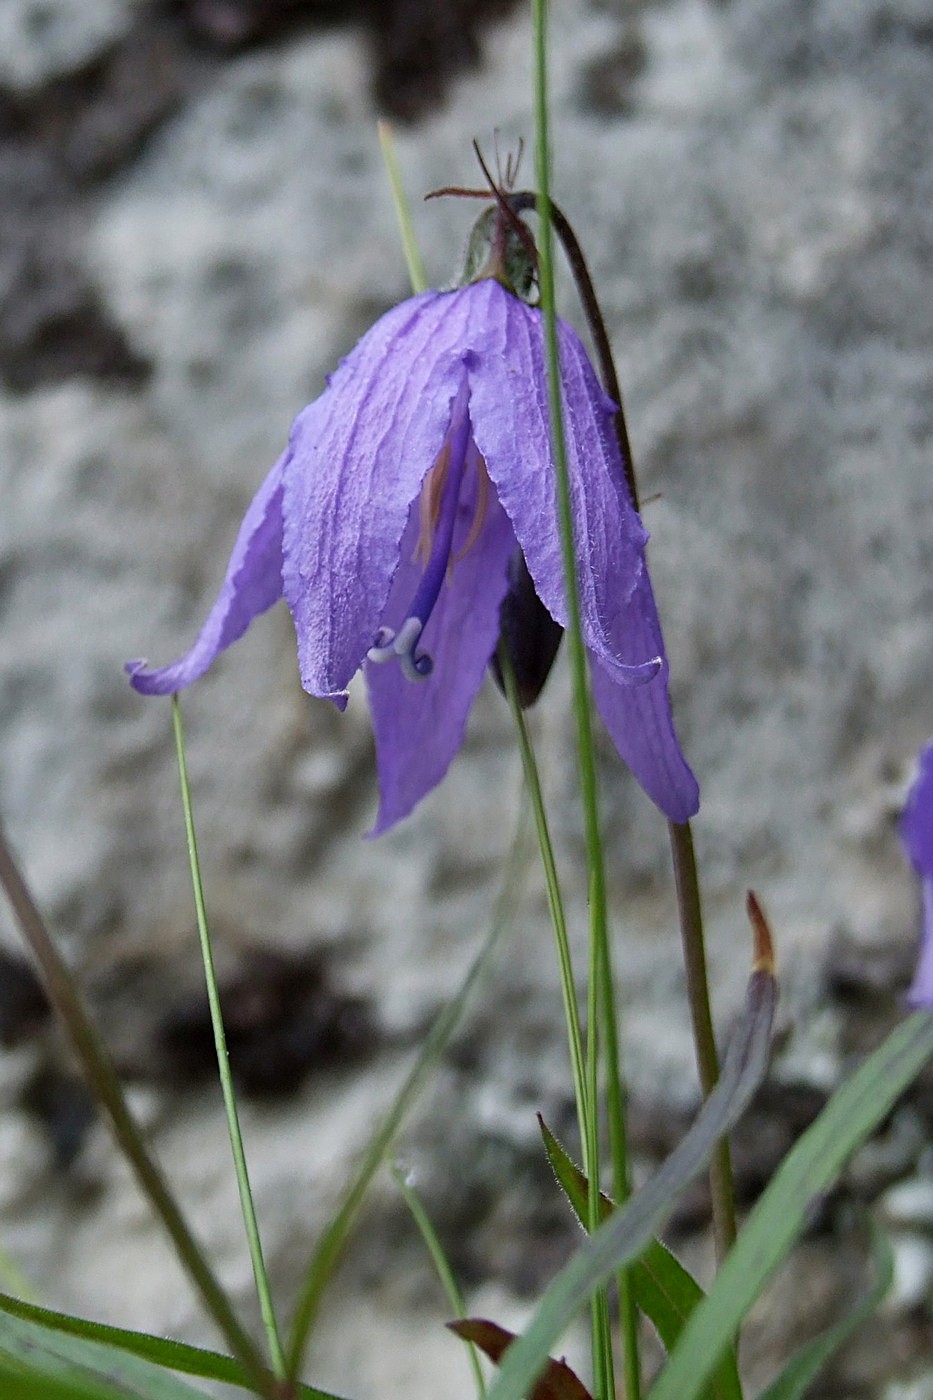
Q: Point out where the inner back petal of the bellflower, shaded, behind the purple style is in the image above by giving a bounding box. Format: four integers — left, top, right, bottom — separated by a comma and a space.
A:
364, 445, 516, 836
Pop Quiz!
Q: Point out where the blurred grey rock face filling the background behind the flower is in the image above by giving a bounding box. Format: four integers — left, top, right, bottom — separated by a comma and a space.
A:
0, 0, 933, 1400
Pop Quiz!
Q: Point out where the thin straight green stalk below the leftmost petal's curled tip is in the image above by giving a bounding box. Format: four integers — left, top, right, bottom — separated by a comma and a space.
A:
172, 694, 286, 1380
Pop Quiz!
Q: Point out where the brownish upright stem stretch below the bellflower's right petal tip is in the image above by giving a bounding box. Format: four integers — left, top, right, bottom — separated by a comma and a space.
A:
668, 822, 735, 1264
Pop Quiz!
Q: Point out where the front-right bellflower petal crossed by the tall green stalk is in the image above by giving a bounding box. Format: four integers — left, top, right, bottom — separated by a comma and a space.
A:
467, 281, 658, 675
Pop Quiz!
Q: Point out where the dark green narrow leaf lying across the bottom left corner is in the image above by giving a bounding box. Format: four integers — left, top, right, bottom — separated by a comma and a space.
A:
0, 1294, 339, 1400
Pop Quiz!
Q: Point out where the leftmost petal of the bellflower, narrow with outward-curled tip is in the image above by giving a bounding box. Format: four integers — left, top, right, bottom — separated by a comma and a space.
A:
125, 452, 287, 696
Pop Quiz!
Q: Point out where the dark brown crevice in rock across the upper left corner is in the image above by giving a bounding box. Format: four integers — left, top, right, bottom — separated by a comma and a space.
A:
0, 0, 514, 392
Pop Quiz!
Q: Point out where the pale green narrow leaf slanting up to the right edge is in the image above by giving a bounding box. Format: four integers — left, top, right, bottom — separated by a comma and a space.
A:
647, 1011, 933, 1400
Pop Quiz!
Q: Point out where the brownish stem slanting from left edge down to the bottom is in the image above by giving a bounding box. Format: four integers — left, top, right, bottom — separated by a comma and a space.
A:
0, 830, 275, 1400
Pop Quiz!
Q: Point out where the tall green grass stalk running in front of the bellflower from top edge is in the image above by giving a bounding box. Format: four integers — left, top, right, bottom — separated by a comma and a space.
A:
532, 0, 640, 1400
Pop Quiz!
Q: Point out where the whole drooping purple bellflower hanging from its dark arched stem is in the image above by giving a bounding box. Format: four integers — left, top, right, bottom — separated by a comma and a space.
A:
126, 210, 699, 834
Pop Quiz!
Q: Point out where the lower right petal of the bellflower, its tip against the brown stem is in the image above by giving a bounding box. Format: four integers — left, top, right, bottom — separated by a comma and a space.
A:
591, 568, 699, 822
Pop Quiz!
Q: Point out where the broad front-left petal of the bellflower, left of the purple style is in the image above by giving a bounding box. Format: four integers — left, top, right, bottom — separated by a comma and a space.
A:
283, 291, 487, 699
